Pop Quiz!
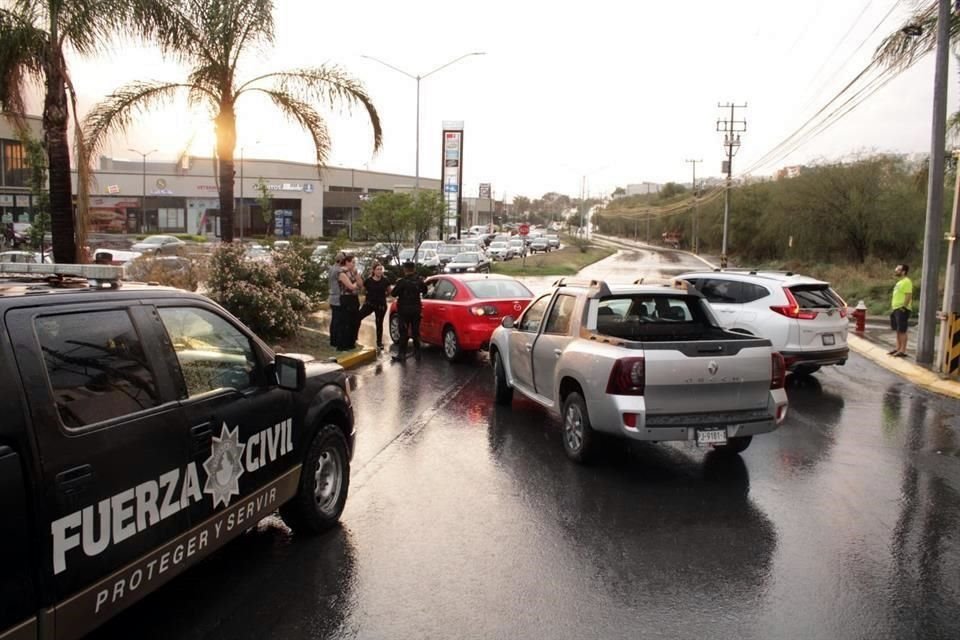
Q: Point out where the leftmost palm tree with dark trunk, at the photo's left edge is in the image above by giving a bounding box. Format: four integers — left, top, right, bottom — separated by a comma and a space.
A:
0, 0, 169, 262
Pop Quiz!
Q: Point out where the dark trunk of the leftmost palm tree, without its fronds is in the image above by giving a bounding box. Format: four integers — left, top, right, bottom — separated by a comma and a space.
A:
43, 58, 77, 264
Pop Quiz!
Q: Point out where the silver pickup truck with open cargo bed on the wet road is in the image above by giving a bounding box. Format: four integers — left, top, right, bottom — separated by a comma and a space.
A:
490, 280, 787, 462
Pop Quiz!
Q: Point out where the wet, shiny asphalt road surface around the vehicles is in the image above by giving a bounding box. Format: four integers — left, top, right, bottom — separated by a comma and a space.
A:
95, 244, 960, 639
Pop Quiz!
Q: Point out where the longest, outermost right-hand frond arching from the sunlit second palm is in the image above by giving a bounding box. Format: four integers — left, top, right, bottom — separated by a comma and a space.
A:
237, 65, 383, 152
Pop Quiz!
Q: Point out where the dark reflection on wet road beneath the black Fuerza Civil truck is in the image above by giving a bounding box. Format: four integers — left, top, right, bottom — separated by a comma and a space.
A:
90, 517, 357, 640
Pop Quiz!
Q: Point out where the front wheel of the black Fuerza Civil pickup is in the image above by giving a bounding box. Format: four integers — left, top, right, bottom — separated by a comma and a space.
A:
280, 424, 350, 534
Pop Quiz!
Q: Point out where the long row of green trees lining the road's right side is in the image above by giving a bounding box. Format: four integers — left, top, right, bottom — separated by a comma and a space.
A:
594, 154, 953, 264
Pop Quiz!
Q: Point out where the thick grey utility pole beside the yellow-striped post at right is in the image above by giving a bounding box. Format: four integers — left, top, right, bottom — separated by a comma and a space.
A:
917, 0, 951, 365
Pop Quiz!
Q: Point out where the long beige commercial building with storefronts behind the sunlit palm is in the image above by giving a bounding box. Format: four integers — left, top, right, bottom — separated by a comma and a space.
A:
79, 157, 440, 238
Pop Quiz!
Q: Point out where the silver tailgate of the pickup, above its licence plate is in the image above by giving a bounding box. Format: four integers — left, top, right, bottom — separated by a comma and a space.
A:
644, 340, 772, 414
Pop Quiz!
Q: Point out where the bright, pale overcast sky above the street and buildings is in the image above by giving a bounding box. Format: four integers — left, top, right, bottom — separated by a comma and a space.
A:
54, 0, 958, 198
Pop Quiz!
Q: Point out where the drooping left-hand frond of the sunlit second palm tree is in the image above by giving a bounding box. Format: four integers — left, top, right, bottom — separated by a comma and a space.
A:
83, 82, 200, 157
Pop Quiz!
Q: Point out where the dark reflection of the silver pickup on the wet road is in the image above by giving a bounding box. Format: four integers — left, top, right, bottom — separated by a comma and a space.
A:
488, 400, 777, 624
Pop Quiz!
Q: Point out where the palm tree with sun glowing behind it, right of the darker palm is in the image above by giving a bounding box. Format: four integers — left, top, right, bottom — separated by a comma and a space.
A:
84, 0, 382, 242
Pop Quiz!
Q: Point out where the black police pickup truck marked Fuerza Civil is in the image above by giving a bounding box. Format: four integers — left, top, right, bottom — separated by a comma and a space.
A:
0, 265, 354, 640
